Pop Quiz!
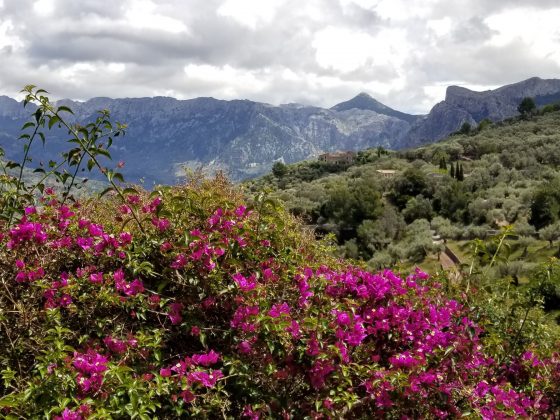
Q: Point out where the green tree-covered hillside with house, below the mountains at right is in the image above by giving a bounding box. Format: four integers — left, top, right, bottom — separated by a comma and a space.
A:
246, 107, 560, 282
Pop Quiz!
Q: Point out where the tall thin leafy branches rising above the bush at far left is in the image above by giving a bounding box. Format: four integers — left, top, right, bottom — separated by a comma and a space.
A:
0, 85, 143, 230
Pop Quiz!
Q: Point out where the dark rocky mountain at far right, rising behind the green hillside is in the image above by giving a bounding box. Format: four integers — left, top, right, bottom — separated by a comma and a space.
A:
395, 77, 560, 148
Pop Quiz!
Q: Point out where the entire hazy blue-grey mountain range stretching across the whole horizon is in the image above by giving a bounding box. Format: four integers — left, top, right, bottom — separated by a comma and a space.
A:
0, 78, 560, 186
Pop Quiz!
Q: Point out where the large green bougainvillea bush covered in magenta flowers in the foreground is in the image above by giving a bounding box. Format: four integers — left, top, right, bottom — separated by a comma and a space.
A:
0, 177, 560, 419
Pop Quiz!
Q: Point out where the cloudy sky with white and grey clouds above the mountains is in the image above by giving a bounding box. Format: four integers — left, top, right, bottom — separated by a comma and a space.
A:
0, 0, 560, 113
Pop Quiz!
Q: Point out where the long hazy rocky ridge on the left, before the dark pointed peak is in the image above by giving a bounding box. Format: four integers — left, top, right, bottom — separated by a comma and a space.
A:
0, 97, 410, 184
